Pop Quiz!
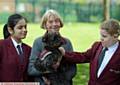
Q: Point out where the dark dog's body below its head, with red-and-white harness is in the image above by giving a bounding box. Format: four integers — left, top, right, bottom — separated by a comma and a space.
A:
35, 50, 62, 73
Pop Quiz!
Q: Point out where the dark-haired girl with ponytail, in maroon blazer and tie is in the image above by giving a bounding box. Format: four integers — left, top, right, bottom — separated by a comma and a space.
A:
0, 14, 31, 82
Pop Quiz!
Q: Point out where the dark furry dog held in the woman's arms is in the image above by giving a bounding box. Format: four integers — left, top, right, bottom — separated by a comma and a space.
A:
35, 32, 65, 73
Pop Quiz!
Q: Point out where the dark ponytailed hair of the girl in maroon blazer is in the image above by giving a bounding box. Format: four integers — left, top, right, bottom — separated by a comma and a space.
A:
3, 14, 27, 39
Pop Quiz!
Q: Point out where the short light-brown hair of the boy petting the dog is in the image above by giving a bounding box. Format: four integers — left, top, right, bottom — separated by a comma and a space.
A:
101, 19, 120, 36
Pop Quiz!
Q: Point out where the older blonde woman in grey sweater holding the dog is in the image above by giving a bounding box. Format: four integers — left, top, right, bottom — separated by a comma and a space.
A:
28, 10, 76, 85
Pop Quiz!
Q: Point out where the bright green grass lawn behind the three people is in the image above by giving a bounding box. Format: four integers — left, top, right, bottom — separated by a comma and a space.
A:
0, 23, 99, 85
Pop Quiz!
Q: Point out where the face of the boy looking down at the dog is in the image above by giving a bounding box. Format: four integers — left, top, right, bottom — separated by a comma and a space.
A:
100, 29, 117, 47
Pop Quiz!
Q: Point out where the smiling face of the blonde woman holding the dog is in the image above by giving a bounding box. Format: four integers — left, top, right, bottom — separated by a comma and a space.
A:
46, 15, 61, 32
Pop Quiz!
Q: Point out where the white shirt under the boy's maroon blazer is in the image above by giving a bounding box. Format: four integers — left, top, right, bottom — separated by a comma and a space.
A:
97, 42, 119, 77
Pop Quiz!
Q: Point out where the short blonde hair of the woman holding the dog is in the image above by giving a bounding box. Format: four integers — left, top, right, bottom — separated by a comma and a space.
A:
41, 9, 63, 29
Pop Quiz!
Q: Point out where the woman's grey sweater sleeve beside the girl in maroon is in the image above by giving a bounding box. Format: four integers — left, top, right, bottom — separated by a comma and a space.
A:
28, 38, 42, 76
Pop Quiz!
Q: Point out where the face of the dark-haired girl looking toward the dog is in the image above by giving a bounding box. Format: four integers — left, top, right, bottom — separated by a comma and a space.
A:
11, 19, 27, 42
